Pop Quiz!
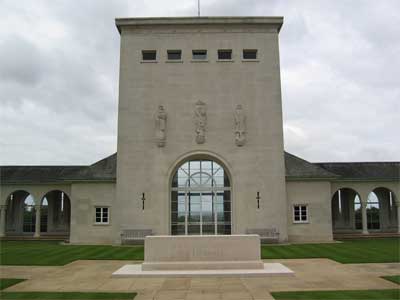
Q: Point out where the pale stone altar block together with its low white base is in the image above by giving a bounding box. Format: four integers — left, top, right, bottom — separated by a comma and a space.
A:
113, 234, 294, 277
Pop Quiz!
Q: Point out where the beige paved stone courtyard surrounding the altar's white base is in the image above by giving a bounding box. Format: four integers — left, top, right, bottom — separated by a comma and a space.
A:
0, 259, 400, 300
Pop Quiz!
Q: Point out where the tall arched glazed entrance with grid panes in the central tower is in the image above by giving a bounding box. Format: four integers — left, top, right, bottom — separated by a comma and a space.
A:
171, 159, 232, 235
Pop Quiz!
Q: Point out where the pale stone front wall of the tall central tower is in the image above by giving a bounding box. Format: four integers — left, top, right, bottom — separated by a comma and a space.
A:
114, 18, 287, 241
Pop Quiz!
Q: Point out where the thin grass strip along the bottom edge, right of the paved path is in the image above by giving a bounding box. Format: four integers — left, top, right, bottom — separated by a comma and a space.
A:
271, 289, 400, 300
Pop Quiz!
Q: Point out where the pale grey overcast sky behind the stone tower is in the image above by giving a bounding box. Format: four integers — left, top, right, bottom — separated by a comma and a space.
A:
0, 0, 400, 165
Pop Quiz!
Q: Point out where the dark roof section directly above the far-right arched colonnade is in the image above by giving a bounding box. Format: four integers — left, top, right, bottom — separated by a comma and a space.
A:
315, 162, 400, 181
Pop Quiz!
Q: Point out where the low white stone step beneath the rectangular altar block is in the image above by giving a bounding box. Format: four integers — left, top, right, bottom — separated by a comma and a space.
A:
112, 263, 294, 278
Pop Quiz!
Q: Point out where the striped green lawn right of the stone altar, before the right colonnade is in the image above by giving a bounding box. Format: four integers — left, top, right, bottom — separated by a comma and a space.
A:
261, 238, 400, 263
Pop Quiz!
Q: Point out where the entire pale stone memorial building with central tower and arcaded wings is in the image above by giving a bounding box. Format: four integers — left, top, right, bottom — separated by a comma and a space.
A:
0, 17, 400, 244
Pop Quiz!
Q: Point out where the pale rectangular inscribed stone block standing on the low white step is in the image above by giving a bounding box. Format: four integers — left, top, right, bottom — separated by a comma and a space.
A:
142, 234, 264, 271
